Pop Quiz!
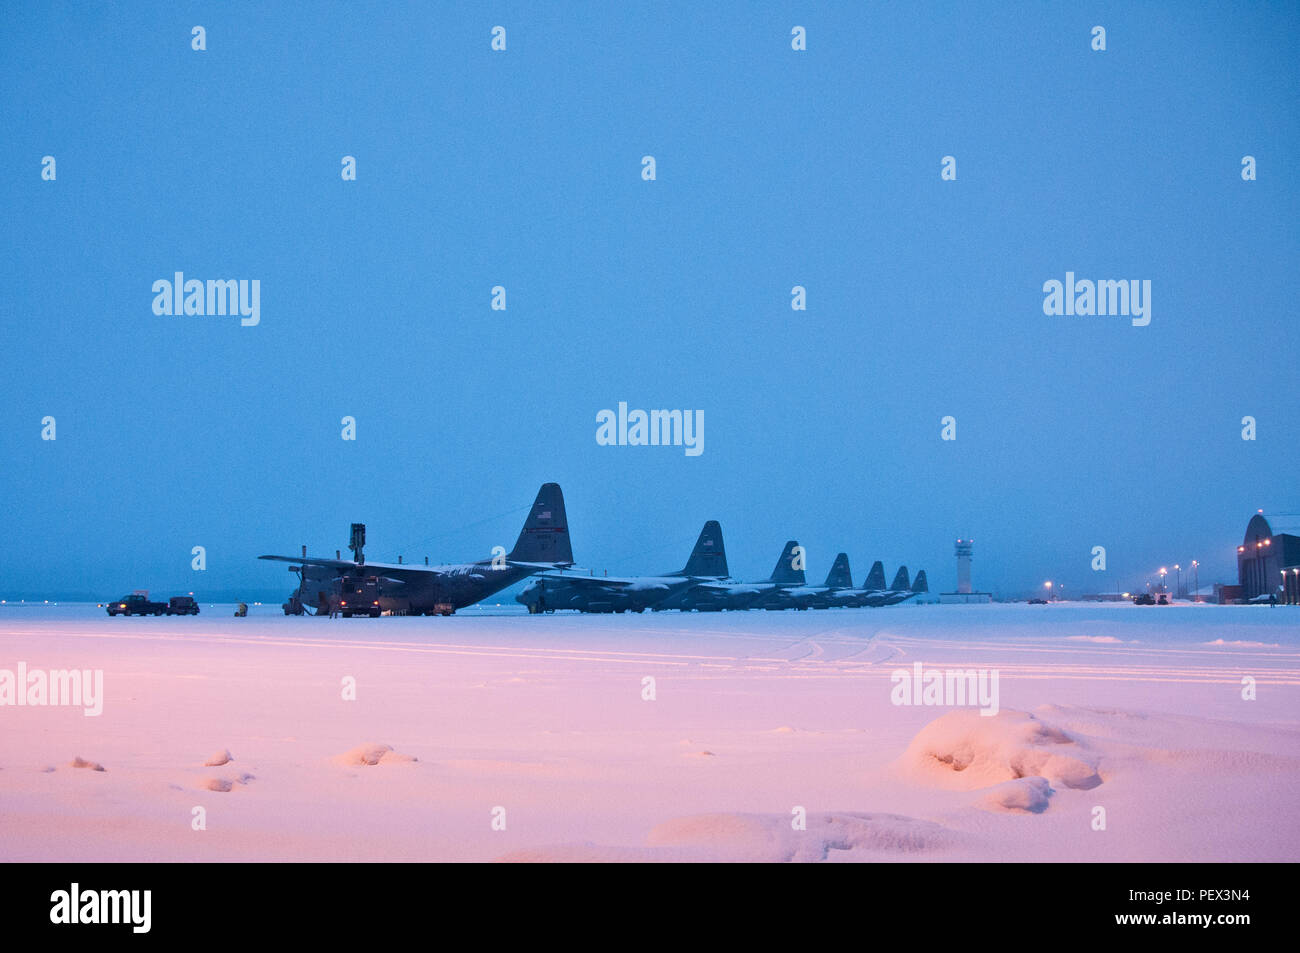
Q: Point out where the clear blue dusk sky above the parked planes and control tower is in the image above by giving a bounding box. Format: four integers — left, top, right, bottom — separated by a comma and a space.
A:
0, 3, 1300, 598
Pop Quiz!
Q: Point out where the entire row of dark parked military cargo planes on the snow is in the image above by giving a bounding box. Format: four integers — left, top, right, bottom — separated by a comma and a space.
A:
260, 484, 928, 616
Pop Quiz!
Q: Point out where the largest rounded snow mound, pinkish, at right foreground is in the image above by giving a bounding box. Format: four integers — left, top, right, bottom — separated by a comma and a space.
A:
900, 710, 1101, 790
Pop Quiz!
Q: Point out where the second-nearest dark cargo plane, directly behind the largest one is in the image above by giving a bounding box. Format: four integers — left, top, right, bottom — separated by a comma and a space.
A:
515, 520, 728, 614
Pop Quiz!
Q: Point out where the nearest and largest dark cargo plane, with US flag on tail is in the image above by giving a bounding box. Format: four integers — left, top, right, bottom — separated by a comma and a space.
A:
259, 484, 573, 616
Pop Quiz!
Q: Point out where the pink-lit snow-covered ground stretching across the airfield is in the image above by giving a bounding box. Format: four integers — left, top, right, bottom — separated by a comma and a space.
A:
0, 605, 1300, 861
